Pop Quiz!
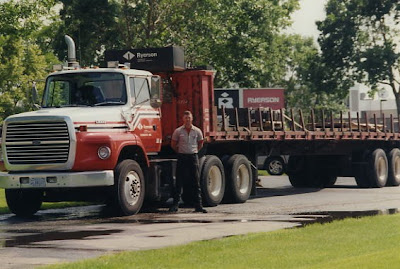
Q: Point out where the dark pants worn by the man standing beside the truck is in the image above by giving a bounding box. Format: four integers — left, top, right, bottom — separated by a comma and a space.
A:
173, 153, 203, 208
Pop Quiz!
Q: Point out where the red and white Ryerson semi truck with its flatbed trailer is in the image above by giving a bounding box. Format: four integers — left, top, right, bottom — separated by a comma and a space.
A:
0, 37, 400, 216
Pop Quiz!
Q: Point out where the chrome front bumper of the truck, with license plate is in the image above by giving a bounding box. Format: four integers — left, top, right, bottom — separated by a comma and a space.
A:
0, 170, 114, 189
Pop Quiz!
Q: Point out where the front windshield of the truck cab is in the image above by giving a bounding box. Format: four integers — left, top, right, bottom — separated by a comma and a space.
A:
42, 72, 127, 107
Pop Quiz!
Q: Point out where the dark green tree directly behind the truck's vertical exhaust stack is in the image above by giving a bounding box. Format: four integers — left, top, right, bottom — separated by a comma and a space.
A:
52, 0, 120, 66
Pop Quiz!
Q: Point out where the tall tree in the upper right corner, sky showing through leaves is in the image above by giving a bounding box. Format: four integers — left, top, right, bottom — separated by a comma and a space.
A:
318, 0, 400, 113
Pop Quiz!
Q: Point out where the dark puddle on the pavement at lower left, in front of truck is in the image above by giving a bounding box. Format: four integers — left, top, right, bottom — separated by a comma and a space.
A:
3, 229, 123, 248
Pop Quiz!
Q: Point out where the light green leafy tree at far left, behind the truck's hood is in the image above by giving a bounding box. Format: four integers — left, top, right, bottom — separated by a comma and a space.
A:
0, 0, 56, 122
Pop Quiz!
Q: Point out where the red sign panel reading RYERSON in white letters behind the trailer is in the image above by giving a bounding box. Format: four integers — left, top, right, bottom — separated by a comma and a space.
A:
243, 89, 285, 109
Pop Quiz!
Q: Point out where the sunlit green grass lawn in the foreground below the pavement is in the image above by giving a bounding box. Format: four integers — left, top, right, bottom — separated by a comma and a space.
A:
46, 215, 400, 269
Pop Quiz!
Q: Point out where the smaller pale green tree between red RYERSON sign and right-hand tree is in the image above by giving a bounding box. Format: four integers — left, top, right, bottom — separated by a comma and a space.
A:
276, 35, 345, 115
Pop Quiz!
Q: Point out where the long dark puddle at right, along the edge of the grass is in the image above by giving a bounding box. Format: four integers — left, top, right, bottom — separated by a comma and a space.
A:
290, 208, 400, 228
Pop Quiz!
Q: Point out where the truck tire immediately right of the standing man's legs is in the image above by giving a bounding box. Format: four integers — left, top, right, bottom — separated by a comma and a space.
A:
200, 155, 225, 206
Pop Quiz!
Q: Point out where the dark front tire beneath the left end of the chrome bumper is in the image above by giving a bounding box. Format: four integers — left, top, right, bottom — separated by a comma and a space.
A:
5, 189, 43, 217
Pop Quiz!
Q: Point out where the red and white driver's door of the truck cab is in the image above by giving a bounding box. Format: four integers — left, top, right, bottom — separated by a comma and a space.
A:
129, 77, 162, 153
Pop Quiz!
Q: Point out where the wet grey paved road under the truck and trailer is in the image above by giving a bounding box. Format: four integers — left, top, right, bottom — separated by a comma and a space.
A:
0, 176, 400, 268
